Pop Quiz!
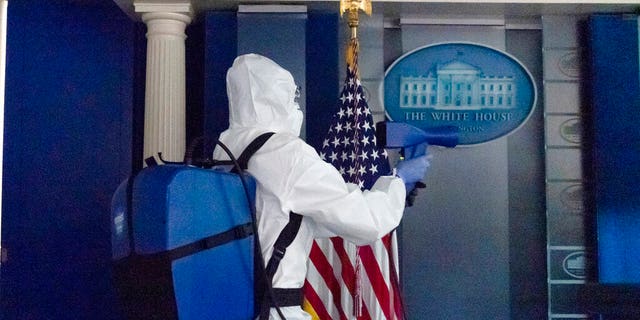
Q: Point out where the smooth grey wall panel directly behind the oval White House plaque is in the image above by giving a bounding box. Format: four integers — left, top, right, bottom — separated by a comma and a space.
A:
400, 25, 510, 319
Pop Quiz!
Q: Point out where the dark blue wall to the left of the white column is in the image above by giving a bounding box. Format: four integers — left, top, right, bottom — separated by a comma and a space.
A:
0, 0, 145, 319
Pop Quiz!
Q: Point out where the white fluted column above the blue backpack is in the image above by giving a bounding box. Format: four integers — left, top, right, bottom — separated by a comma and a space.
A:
134, 2, 191, 161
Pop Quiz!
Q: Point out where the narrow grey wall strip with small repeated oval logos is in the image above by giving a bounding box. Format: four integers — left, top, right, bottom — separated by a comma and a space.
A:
542, 15, 595, 320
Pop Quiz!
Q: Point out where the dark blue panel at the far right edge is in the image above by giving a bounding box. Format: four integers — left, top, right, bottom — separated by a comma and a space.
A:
589, 15, 640, 285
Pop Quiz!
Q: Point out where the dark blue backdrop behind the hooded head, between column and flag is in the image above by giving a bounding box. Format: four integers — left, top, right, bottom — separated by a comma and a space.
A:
200, 11, 343, 148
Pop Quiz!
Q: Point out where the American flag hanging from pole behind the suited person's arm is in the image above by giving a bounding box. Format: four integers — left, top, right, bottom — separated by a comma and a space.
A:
304, 41, 402, 320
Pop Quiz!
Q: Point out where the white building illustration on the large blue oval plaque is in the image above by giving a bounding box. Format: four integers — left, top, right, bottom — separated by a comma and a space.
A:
400, 59, 516, 110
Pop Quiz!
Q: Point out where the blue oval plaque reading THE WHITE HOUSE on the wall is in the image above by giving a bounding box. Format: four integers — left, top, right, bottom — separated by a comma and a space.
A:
383, 42, 537, 145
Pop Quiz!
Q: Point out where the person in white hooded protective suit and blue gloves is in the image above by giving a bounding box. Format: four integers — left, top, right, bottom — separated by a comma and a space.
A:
214, 54, 428, 320
